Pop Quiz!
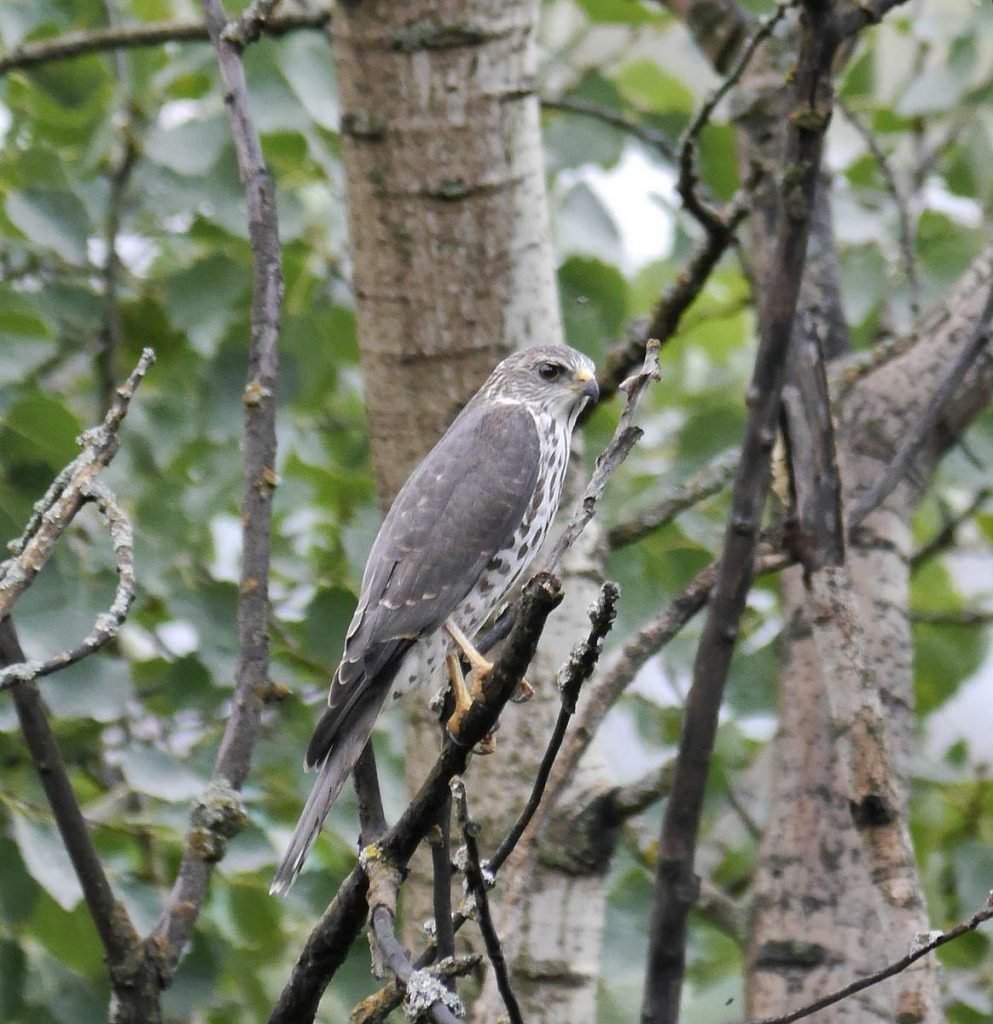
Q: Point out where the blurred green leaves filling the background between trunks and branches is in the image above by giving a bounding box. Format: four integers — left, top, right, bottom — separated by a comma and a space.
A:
0, 0, 993, 1024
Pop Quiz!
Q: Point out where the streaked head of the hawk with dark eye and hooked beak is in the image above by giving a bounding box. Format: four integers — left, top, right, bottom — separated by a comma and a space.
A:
480, 345, 600, 427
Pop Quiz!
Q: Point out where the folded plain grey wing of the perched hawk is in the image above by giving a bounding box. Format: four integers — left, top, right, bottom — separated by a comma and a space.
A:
306, 402, 539, 765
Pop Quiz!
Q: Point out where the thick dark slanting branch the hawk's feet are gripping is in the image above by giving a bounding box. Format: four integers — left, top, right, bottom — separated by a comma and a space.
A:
269, 573, 562, 1024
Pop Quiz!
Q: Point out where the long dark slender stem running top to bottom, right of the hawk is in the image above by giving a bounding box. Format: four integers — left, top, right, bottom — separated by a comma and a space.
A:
642, 2, 839, 1024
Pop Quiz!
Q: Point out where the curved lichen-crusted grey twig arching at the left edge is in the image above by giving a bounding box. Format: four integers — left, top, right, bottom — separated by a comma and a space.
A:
0, 480, 135, 691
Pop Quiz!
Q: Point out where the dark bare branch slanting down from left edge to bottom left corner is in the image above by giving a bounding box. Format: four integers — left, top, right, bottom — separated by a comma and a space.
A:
0, 617, 161, 1024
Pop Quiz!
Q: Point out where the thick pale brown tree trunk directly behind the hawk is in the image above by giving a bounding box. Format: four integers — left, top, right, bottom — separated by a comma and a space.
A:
333, 0, 604, 1024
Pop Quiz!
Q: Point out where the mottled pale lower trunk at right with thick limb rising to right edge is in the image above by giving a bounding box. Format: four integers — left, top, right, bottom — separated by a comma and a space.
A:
748, 252, 993, 1024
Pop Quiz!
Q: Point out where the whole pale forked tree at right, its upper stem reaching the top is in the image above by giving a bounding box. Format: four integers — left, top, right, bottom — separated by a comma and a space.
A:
671, 0, 989, 1024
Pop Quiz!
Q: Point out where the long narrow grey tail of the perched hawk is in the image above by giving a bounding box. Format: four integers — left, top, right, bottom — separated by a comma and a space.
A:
269, 688, 388, 896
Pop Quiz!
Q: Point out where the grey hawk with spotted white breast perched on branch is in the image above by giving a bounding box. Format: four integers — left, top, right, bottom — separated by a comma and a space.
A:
270, 345, 598, 893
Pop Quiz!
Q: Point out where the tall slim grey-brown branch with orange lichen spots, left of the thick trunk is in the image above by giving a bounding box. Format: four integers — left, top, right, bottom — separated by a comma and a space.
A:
156, 0, 283, 967
